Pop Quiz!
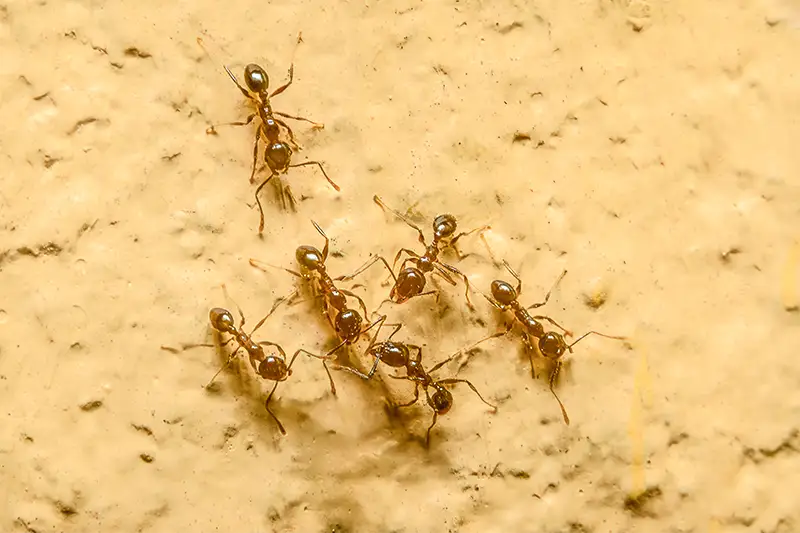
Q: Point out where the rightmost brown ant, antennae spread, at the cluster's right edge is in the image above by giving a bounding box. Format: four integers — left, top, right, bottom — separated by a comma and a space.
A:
484, 260, 627, 425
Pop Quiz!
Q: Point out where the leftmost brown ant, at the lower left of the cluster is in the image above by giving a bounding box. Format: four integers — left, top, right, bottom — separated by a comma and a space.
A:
162, 287, 336, 435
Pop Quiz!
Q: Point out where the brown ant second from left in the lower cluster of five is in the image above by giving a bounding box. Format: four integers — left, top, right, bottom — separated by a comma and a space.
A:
250, 220, 396, 357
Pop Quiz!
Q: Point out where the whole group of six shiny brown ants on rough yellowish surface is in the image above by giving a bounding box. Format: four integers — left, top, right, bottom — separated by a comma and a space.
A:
163, 36, 625, 445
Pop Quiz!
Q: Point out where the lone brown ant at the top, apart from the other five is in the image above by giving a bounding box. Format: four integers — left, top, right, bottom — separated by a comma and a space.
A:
197, 33, 341, 231
